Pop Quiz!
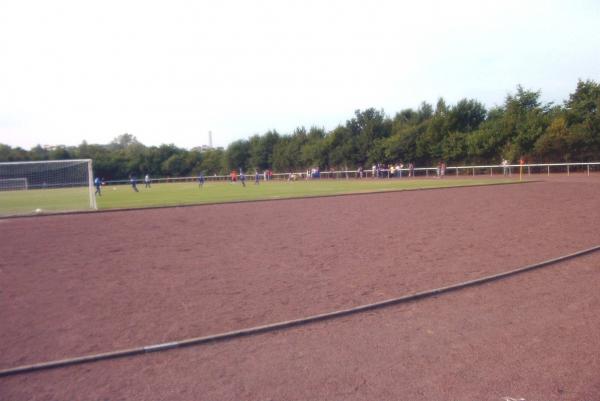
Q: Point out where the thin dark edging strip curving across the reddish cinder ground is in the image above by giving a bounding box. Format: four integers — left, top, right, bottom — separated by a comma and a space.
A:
0, 245, 600, 377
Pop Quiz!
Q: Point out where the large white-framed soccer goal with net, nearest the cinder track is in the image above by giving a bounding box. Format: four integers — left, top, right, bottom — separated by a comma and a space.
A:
0, 159, 96, 216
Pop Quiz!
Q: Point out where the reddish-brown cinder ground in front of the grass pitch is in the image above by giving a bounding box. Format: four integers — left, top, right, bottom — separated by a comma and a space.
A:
0, 177, 600, 401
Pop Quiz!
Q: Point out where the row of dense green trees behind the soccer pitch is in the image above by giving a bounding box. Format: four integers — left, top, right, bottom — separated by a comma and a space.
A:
0, 80, 600, 179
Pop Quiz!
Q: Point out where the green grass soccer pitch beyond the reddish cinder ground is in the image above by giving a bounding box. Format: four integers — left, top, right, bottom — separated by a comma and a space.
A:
0, 178, 518, 216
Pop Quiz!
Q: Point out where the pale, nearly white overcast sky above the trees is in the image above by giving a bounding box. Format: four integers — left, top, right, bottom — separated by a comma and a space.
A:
0, 0, 600, 148
